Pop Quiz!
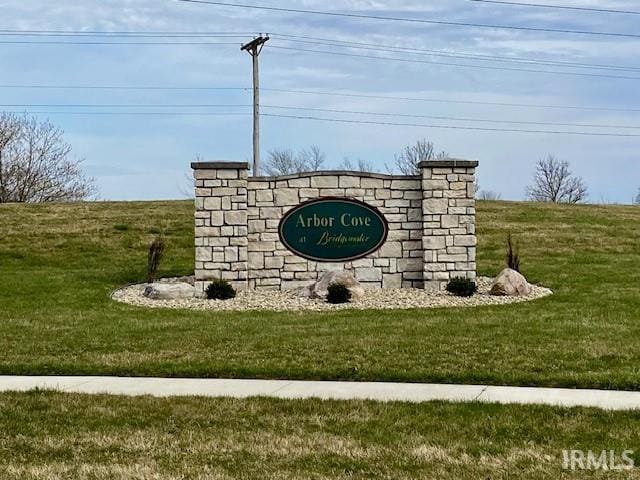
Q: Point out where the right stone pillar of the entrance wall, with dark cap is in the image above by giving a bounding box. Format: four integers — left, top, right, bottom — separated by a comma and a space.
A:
420, 159, 478, 290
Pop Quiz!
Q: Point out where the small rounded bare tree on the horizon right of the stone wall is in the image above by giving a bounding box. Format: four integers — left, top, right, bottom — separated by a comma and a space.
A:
526, 155, 587, 203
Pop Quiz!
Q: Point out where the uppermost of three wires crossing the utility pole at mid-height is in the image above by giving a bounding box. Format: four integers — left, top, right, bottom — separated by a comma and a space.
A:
0, 84, 640, 113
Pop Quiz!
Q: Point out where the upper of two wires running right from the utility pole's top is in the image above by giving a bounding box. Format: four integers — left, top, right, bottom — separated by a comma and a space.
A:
275, 33, 640, 71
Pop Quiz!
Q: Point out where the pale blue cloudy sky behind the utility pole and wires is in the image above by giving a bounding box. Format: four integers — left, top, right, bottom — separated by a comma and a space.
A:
0, 0, 640, 203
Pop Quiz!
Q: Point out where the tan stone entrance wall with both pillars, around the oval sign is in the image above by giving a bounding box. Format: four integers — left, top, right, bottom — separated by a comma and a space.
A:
192, 160, 477, 293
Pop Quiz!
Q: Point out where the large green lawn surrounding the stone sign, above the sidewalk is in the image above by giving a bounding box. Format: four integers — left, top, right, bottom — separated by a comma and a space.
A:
0, 202, 640, 390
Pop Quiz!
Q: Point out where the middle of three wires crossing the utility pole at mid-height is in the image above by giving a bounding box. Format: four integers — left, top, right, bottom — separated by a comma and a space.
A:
6, 103, 640, 130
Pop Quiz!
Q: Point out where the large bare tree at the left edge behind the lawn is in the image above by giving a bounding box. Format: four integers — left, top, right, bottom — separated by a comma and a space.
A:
0, 113, 96, 203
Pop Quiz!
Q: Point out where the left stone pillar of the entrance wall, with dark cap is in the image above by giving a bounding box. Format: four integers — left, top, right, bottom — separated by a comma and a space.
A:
191, 162, 249, 296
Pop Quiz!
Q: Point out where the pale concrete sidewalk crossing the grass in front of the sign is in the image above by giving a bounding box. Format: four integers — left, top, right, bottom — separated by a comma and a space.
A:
0, 376, 640, 410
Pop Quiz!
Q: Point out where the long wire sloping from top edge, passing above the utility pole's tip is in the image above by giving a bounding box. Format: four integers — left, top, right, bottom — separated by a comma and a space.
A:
176, 0, 640, 38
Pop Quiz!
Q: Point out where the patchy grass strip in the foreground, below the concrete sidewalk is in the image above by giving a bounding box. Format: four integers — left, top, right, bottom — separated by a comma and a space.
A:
0, 392, 640, 480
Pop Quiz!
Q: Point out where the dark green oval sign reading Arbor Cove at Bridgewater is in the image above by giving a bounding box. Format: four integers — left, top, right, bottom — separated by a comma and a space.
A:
278, 197, 389, 262
